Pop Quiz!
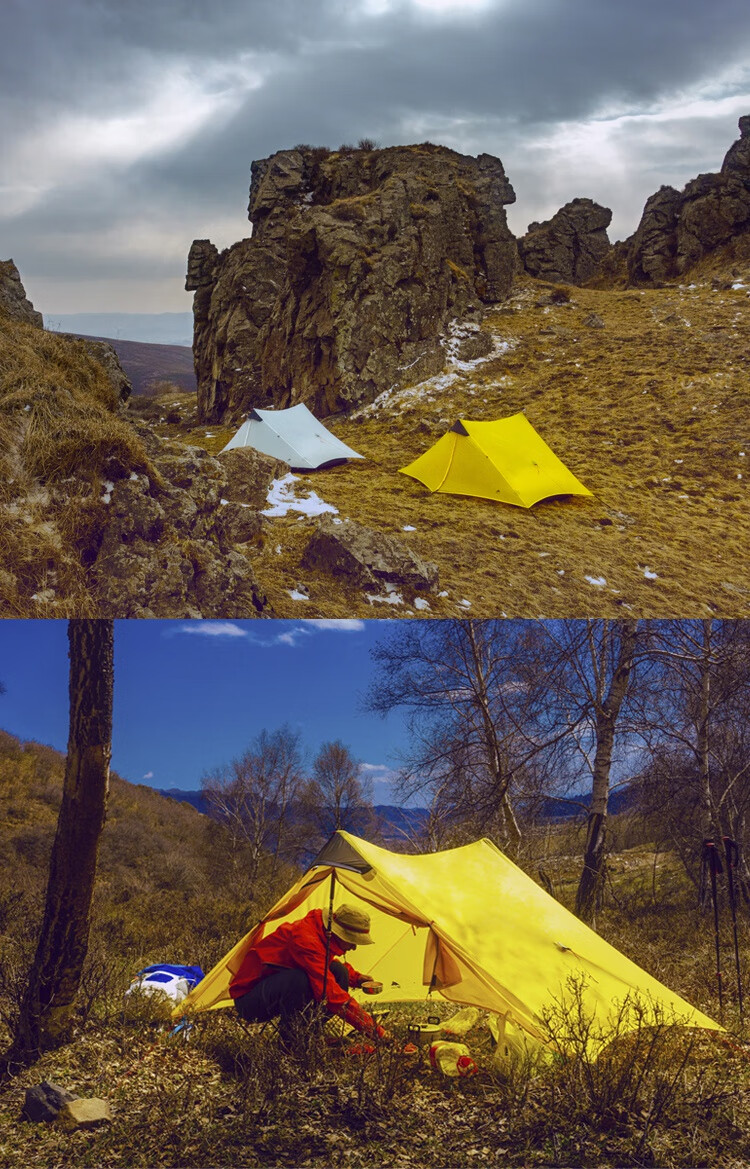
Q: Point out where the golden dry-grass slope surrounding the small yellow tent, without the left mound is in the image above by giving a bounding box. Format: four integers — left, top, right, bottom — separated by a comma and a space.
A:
154, 262, 750, 617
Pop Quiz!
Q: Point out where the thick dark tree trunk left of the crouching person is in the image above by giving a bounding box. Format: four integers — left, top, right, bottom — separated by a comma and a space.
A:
2, 621, 113, 1070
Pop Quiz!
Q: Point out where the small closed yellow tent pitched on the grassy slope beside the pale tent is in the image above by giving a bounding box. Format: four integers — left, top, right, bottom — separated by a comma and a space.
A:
401, 414, 591, 507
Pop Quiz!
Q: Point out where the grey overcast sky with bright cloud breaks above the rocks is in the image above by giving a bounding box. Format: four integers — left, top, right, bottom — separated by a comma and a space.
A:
0, 0, 750, 313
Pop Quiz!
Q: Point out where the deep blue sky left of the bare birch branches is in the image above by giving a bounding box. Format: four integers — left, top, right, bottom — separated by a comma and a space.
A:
0, 621, 405, 803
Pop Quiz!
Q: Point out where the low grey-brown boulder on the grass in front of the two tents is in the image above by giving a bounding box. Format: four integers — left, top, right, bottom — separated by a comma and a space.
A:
300, 516, 438, 592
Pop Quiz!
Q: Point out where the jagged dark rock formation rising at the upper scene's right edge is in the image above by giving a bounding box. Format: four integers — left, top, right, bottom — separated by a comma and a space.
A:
627, 115, 750, 284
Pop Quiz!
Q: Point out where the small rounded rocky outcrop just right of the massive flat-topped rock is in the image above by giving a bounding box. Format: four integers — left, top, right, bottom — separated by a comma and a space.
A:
519, 199, 612, 284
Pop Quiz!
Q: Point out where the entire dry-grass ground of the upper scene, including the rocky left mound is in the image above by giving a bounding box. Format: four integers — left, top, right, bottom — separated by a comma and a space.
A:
0, 236, 750, 618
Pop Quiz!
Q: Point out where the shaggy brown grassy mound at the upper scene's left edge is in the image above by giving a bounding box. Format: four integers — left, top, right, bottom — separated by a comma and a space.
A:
0, 311, 153, 617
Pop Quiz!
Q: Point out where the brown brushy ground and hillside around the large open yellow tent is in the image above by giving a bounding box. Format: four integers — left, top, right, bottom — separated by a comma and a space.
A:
0, 734, 750, 1169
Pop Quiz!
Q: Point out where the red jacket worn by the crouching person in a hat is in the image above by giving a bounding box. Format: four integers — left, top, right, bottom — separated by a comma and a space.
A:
229, 909, 382, 1033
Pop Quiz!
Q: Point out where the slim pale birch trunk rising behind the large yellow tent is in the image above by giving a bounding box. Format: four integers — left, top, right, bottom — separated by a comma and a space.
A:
576, 621, 637, 924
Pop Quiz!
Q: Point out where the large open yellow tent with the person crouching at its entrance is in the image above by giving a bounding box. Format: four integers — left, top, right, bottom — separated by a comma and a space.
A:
174, 831, 721, 1039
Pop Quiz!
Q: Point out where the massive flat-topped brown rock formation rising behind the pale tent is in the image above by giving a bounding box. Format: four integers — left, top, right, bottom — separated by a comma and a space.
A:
186, 144, 518, 422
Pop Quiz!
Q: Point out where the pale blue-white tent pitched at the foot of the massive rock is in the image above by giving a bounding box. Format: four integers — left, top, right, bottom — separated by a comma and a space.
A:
222, 402, 364, 471
